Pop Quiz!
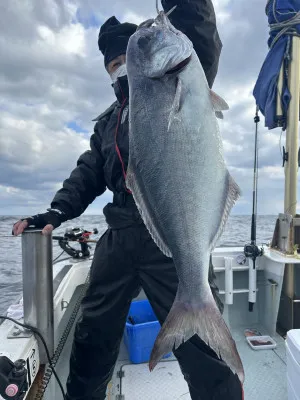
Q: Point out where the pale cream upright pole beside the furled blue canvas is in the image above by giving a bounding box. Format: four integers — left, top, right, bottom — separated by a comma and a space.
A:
284, 37, 300, 299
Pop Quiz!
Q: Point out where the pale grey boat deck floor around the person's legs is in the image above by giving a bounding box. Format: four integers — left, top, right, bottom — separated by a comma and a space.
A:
45, 314, 287, 400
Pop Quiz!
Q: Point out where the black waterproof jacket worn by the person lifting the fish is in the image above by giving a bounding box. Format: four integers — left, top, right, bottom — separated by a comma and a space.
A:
51, 0, 222, 228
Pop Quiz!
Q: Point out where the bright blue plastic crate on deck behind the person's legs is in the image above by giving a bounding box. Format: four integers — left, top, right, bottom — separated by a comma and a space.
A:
124, 300, 172, 364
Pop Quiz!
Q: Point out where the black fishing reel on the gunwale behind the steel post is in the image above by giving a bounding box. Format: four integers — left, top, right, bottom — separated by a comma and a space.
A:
53, 228, 98, 259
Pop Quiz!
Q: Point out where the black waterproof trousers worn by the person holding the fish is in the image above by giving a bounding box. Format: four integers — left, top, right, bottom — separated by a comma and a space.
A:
67, 225, 242, 400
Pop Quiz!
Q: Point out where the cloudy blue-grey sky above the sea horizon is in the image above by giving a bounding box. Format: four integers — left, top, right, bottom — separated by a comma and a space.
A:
0, 0, 294, 215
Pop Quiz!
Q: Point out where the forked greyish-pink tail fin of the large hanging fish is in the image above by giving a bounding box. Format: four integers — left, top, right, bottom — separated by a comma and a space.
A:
149, 295, 244, 383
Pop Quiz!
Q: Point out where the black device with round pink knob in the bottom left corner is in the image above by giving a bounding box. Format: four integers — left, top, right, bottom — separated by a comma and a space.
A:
0, 356, 28, 400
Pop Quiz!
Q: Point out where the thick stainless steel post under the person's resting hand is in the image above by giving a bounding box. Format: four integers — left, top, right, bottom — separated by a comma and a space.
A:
22, 229, 54, 364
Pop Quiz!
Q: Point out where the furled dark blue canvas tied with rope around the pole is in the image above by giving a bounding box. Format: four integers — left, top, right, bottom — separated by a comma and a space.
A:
253, 0, 300, 130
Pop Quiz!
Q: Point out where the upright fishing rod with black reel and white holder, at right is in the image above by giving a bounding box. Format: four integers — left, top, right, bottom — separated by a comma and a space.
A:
244, 106, 263, 312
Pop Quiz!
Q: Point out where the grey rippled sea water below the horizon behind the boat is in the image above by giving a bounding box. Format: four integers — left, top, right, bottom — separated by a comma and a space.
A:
0, 215, 277, 314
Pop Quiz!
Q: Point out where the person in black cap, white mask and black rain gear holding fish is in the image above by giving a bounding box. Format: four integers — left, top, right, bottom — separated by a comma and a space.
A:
13, 0, 243, 400
